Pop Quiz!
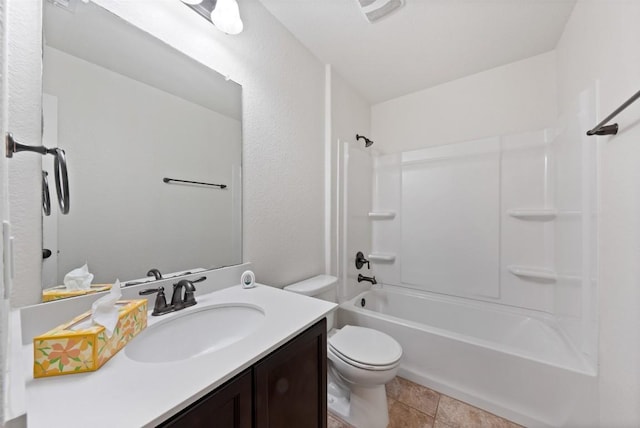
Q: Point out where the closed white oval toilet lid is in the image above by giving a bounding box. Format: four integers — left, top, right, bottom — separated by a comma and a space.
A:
329, 325, 402, 366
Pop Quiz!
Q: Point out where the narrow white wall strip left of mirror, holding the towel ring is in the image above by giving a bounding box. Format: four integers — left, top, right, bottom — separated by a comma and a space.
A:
3, 0, 42, 306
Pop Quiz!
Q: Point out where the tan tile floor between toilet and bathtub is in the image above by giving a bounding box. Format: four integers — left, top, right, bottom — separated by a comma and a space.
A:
328, 377, 520, 428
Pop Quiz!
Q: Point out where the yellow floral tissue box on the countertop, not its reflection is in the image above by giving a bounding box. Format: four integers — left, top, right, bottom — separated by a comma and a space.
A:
33, 299, 147, 378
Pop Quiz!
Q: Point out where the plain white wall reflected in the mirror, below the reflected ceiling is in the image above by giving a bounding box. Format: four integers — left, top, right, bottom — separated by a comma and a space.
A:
43, 47, 242, 287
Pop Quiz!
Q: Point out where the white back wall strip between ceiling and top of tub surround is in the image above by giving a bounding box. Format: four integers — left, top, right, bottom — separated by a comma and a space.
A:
371, 52, 557, 153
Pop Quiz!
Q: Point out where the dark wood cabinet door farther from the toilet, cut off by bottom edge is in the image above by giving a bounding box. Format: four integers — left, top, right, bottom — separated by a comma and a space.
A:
159, 369, 253, 428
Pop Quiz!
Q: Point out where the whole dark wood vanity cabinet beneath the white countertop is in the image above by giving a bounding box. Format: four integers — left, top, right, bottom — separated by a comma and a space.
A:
160, 319, 327, 428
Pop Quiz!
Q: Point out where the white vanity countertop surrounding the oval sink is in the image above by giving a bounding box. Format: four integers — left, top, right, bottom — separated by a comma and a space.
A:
23, 285, 337, 428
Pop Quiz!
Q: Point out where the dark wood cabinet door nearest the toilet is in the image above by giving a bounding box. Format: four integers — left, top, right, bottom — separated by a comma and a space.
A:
254, 319, 327, 428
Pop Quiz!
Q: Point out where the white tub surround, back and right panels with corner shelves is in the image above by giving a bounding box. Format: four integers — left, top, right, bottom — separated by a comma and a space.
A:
368, 119, 597, 358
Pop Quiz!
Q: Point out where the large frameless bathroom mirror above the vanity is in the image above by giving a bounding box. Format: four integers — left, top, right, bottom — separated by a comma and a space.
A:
43, 0, 242, 300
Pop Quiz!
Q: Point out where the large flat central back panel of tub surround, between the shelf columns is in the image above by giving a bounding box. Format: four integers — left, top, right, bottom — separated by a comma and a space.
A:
402, 137, 501, 298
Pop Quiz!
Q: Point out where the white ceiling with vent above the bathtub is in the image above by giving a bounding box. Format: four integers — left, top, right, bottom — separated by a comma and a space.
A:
260, 0, 575, 103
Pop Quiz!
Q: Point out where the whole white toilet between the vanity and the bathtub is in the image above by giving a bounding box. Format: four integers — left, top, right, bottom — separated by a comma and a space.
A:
284, 275, 402, 428
